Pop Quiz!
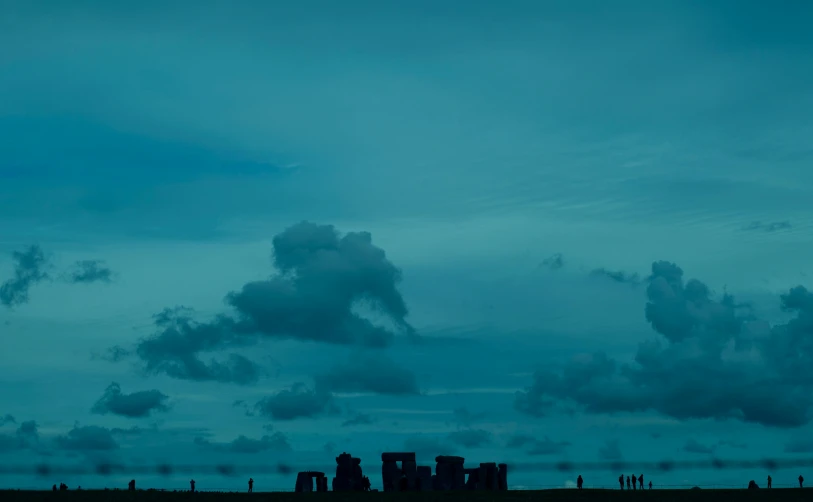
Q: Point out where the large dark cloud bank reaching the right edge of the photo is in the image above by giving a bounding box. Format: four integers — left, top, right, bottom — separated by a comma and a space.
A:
514, 261, 813, 427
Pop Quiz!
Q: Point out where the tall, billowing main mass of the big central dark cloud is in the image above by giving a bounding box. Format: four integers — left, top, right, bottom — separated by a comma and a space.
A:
227, 222, 413, 347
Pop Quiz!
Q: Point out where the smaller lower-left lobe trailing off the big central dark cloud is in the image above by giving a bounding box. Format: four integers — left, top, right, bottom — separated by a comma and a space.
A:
135, 307, 262, 385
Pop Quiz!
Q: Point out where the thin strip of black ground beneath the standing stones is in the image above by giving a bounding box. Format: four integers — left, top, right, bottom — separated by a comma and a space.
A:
0, 488, 813, 502
